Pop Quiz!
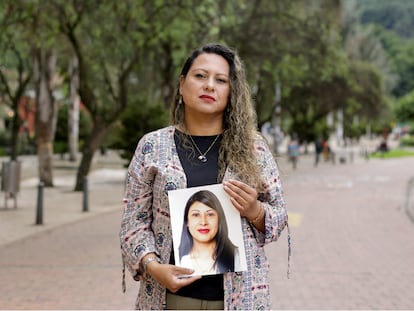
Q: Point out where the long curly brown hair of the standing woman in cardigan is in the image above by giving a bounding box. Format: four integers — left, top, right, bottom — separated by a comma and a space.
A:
170, 43, 262, 191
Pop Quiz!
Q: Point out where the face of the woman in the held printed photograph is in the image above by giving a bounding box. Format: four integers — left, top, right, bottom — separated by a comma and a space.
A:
187, 201, 218, 243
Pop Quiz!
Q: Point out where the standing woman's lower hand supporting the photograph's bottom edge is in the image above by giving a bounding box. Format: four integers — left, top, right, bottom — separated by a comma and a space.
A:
147, 261, 201, 293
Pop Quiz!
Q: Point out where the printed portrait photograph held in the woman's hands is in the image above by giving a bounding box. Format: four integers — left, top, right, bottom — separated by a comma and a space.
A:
168, 184, 247, 275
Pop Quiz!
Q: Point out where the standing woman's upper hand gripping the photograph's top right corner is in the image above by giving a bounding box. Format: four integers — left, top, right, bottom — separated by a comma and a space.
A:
223, 179, 261, 220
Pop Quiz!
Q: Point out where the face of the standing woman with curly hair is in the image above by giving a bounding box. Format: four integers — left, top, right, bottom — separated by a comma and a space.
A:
180, 53, 230, 116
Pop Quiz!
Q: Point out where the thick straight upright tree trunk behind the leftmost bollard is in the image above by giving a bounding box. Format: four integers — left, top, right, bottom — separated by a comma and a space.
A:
33, 48, 56, 187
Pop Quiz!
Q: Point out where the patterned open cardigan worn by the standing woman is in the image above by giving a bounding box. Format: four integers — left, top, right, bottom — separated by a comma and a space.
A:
120, 126, 290, 310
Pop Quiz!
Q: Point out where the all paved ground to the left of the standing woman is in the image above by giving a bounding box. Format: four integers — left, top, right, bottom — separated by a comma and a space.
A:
0, 152, 138, 310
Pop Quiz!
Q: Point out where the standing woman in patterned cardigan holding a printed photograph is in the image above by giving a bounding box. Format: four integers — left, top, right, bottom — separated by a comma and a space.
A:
120, 44, 287, 309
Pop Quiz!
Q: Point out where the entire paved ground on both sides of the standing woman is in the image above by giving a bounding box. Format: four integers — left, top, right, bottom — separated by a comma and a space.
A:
0, 149, 414, 309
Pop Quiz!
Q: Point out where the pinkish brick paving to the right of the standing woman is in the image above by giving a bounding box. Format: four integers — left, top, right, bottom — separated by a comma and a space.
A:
268, 152, 414, 310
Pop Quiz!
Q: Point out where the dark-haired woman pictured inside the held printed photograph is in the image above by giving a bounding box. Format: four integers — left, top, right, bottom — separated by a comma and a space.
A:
179, 190, 238, 275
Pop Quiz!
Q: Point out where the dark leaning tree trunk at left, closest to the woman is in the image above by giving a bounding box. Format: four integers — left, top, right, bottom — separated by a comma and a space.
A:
74, 124, 109, 191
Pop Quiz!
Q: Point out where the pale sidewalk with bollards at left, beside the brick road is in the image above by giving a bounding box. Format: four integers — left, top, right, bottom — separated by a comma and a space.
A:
0, 151, 126, 249
